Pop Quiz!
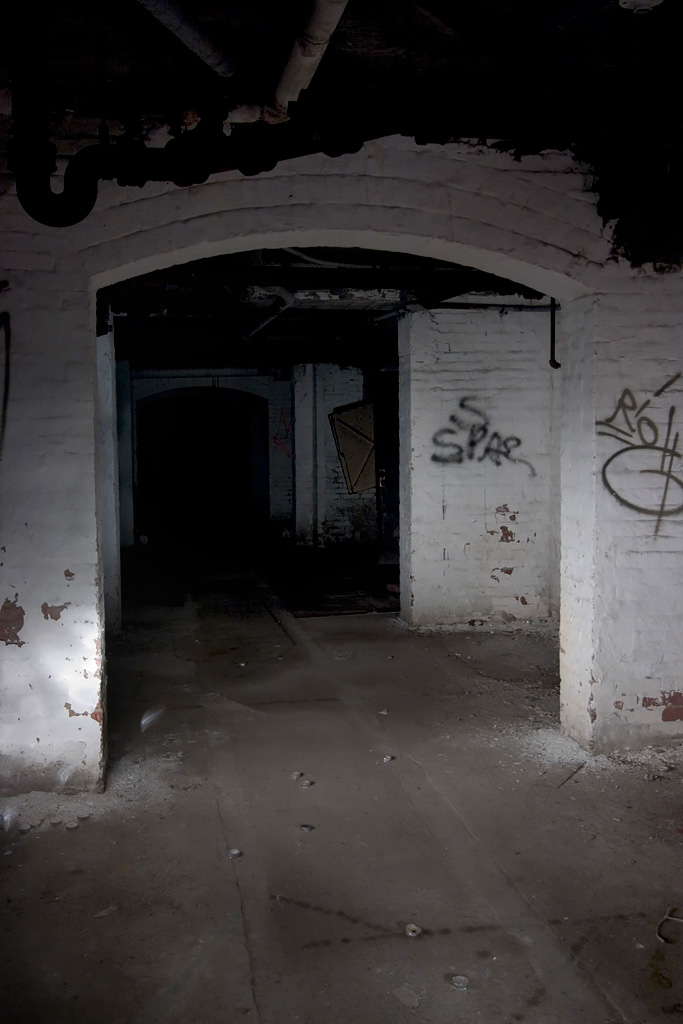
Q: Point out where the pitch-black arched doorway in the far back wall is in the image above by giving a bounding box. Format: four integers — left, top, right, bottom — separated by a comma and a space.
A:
135, 387, 268, 564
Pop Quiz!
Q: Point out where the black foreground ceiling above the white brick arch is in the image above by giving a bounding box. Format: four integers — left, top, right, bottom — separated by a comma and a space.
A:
5, 0, 683, 269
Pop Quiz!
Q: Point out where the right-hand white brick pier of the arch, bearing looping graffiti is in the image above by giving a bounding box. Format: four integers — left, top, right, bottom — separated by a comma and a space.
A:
559, 288, 683, 753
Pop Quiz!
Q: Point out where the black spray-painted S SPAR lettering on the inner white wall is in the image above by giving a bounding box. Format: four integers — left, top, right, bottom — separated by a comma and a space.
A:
432, 397, 536, 476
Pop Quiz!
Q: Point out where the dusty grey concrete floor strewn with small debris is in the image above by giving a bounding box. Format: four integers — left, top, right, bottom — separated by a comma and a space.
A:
0, 579, 683, 1024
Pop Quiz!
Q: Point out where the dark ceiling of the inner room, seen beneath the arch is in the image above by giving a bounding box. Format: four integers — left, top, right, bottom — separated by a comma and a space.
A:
105, 249, 545, 372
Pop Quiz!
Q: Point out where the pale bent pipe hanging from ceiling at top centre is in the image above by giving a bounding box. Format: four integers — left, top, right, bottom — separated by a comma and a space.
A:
228, 0, 348, 124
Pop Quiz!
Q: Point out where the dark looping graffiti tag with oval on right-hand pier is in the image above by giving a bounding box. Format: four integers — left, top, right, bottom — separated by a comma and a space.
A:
597, 373, 683, 537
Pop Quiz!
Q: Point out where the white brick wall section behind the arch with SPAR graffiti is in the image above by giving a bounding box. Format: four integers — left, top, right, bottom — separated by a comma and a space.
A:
401, 307, 558, 625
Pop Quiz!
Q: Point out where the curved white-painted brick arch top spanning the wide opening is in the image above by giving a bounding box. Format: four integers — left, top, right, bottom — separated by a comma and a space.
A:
69, 138, 609, 299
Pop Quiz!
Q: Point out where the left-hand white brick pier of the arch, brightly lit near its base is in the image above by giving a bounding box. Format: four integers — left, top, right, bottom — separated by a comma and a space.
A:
0, 253, 104, 792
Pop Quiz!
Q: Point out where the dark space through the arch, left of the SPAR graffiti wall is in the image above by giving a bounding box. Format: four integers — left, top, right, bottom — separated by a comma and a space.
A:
98, 248, 536, 615
